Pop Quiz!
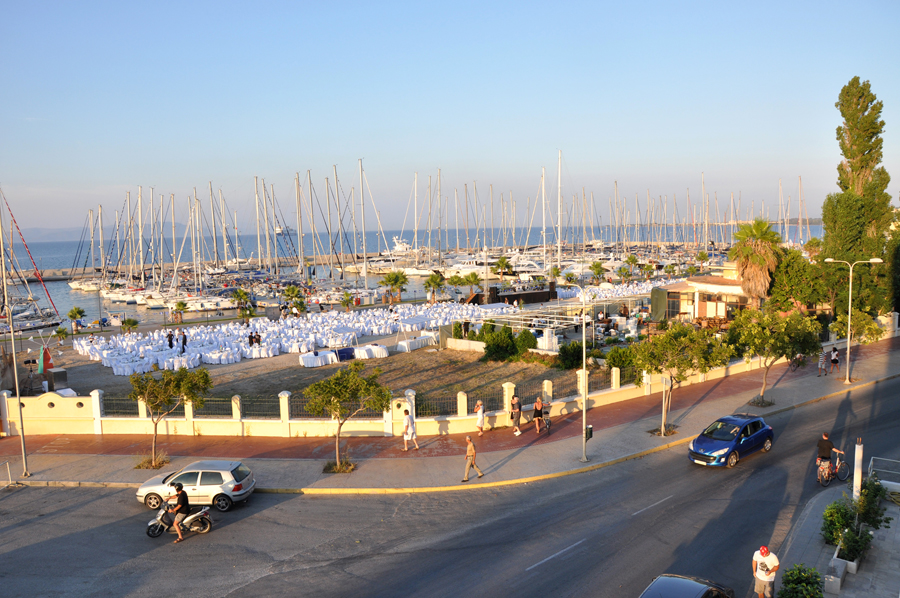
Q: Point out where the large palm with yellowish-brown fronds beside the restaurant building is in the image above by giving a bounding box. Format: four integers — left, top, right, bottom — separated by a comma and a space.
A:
728, 218, 781, 307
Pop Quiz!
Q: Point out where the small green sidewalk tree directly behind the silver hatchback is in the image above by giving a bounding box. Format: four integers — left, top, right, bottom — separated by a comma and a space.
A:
128, 368, 213, 468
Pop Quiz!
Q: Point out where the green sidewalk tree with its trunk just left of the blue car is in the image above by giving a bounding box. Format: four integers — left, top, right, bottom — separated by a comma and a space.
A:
631, 322, 732, 436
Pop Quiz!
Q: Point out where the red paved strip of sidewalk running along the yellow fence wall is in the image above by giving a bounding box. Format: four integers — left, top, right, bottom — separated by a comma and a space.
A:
0, 337, 900, 459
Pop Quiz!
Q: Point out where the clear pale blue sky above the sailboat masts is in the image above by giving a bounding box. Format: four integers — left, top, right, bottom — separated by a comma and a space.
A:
0, 0, 900, 237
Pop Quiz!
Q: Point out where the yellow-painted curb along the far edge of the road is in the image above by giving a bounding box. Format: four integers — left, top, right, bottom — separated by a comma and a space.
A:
19, 373, 900, 496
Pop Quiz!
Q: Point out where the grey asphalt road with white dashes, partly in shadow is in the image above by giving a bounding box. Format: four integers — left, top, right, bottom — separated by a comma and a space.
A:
0, 380, 900, 598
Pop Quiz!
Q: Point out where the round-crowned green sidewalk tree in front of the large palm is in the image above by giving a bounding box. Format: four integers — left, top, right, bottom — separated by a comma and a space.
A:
728, 305, 822, 402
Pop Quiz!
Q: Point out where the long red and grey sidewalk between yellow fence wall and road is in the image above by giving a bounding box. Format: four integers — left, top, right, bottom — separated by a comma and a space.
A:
0, 338, 900, 494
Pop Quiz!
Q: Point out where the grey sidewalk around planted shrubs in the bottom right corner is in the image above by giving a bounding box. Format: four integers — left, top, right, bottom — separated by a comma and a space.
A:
775, 482, 900, 598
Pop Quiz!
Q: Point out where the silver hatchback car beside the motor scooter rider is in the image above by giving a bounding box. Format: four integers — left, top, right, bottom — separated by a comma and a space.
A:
137, 461, 256, 511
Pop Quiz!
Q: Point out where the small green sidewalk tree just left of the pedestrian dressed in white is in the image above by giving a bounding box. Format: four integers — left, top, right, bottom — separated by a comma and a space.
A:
303, 361, 391, 467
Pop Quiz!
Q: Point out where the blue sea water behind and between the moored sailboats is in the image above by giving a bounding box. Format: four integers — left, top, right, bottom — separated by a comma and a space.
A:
8, 224, 823, 324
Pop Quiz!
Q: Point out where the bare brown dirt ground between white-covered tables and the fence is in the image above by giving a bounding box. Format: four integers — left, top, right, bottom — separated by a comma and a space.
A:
53, 345, 575, 398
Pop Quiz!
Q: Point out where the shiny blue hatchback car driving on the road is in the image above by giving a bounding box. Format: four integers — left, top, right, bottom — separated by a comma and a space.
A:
688, 413, 773, 467
